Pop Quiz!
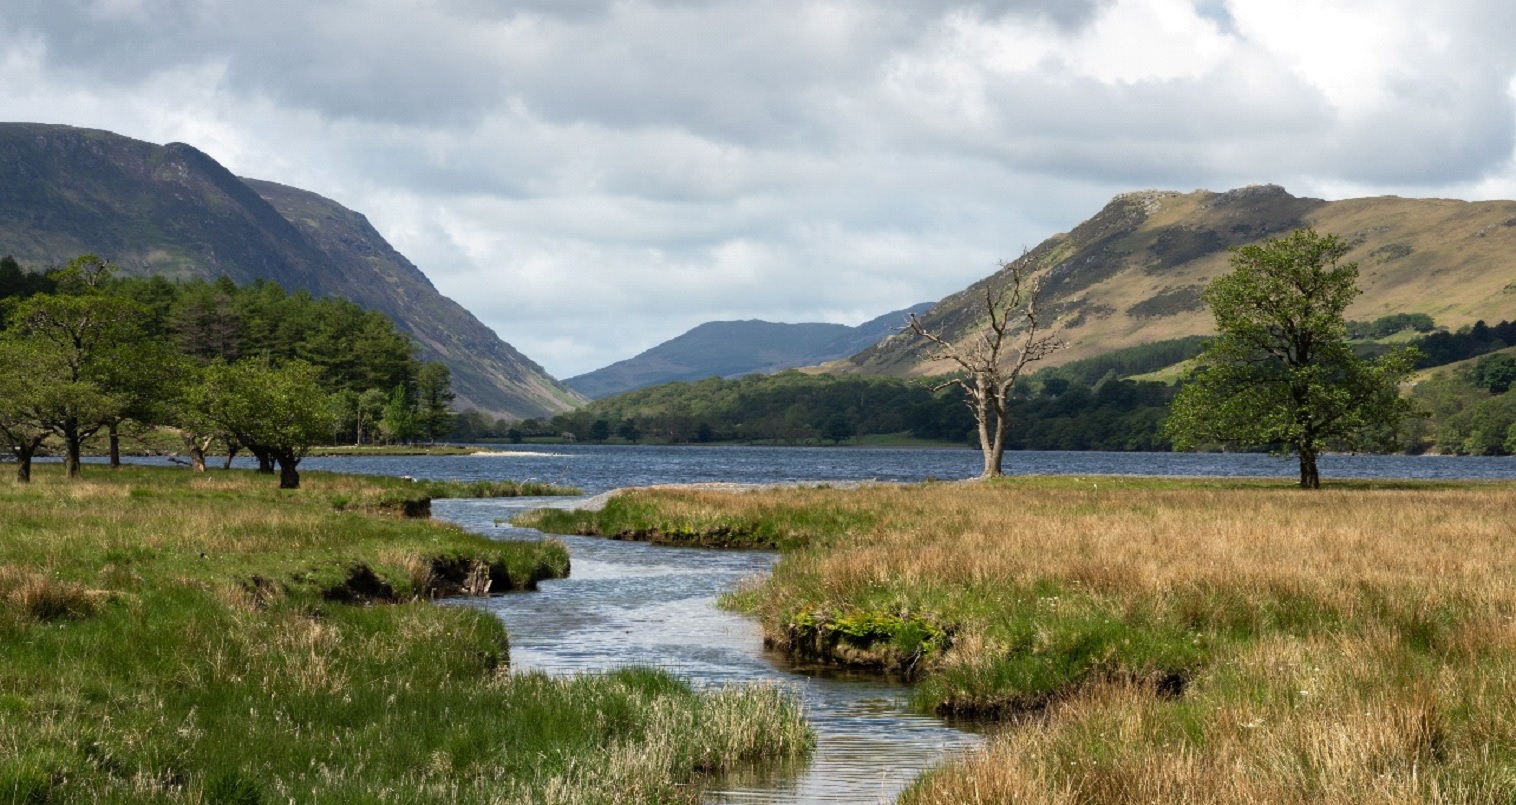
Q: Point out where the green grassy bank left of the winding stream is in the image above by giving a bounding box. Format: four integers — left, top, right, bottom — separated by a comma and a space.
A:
0, 465, 811, 803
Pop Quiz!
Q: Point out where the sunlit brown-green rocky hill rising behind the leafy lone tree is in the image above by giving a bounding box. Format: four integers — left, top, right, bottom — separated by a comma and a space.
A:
848, 185, 1516, 376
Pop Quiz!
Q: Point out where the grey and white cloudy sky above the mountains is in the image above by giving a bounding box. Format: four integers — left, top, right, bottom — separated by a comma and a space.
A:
0, 0, 1516, 377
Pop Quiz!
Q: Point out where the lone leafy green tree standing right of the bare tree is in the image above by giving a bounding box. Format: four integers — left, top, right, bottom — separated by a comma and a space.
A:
1164, 229, 1416, 490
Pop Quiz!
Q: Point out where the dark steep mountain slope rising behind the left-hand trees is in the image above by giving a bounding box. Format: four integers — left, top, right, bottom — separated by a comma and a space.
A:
0, 123, 584, 418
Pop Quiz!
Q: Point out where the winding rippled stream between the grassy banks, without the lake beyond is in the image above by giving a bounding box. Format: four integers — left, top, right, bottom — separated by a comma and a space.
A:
434, 499, 976, 803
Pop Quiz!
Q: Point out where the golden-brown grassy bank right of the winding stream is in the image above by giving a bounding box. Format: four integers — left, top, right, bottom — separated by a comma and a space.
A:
524, 478, 1516, 805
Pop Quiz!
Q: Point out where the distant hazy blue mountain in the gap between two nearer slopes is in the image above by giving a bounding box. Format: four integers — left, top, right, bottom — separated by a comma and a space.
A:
564, 305, 931, 399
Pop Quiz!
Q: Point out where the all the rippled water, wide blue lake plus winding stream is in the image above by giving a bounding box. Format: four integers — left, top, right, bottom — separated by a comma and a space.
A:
109, 446, 1516, 803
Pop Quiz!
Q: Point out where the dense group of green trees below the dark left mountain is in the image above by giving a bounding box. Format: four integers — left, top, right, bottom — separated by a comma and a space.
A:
0, 255, 453, 485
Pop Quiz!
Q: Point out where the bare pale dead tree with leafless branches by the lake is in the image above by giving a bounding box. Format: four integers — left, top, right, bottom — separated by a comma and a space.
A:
907, 259, 1064, 478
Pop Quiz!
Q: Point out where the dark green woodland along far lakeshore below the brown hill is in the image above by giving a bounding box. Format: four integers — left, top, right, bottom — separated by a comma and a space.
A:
524, 314, 1516, 455
